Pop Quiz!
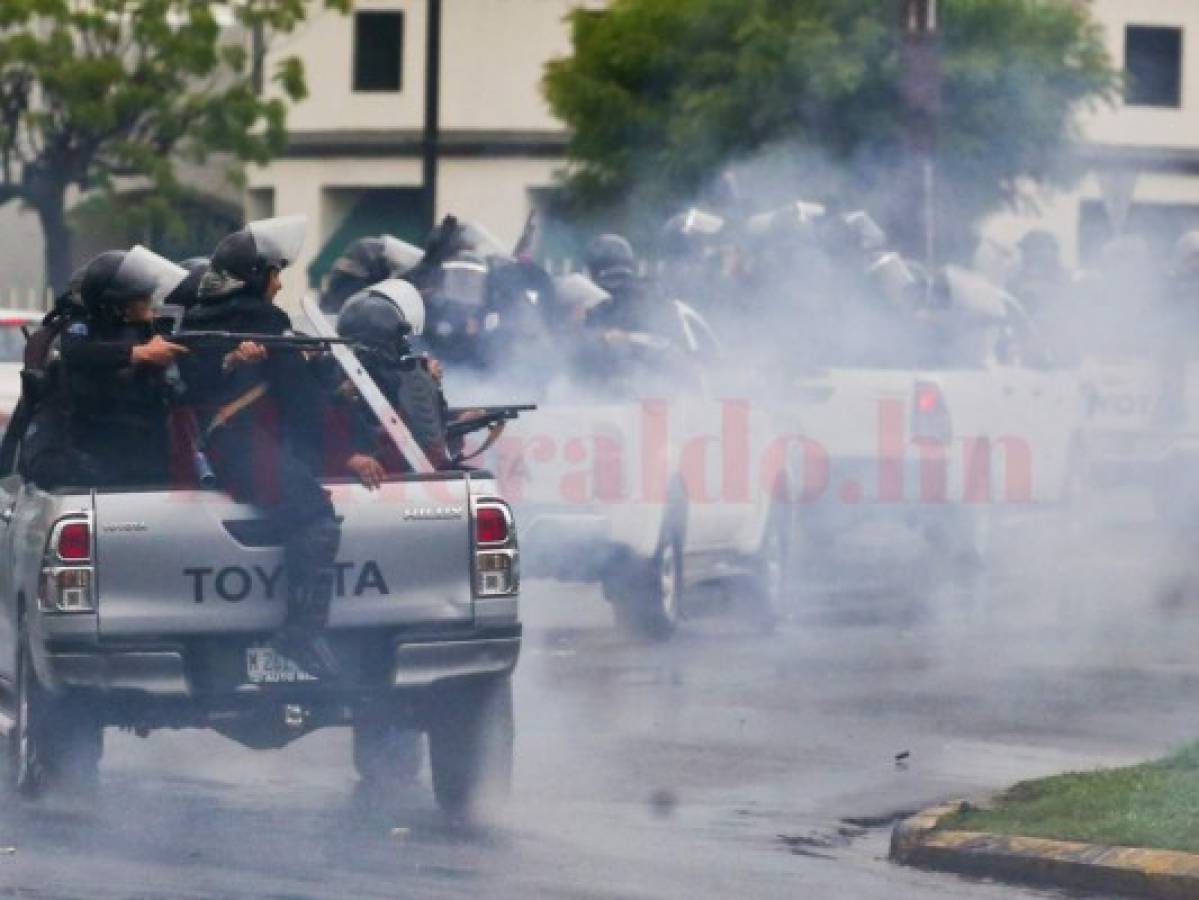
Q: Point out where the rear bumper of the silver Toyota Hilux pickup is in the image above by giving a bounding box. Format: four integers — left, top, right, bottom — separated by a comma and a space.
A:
37, 626, 520, 705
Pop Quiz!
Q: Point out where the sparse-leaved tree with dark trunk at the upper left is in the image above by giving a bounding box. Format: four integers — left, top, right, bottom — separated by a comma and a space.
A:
0, 0, 350, 290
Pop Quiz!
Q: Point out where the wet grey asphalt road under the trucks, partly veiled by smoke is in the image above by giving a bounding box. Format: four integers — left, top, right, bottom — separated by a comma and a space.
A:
0, 496, 1199, 899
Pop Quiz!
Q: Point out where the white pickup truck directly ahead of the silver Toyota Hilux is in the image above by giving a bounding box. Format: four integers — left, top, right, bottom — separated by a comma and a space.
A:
477, 303, 794, 640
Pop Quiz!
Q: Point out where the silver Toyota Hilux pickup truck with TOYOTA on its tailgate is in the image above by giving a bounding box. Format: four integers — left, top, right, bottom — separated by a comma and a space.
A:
0, 300, 520, 814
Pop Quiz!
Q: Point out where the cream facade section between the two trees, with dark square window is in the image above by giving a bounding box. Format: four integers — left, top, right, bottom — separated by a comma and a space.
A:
246, 0, 600, 299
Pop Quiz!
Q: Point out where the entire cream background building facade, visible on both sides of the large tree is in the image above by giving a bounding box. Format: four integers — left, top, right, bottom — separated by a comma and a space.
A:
0, 0, 1184, 303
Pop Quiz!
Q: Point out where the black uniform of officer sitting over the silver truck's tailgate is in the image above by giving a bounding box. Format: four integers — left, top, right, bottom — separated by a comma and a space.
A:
183, 288, 341, 629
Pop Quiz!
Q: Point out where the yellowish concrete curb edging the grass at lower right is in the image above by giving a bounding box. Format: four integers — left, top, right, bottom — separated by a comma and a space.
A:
891, 801, 1199, 900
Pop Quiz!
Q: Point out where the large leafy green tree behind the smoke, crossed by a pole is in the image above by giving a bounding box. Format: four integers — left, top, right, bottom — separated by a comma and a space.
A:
543, 0, 1119, 254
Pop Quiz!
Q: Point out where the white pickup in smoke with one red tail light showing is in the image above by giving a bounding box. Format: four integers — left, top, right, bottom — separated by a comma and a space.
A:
789, 263, 1081, 560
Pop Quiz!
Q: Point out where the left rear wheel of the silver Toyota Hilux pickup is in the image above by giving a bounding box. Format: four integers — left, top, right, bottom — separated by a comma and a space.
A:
4, 623, 104, 798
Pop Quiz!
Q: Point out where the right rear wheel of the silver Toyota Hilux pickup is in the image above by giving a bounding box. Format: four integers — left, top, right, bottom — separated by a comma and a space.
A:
428, 675, 514, 819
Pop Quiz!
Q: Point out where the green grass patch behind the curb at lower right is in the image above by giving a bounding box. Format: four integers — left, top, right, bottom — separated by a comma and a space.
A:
940, 743, 1199, 852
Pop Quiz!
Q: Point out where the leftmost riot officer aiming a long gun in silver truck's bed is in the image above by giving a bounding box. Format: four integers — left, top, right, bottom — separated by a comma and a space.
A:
23, 247, 187, 485
